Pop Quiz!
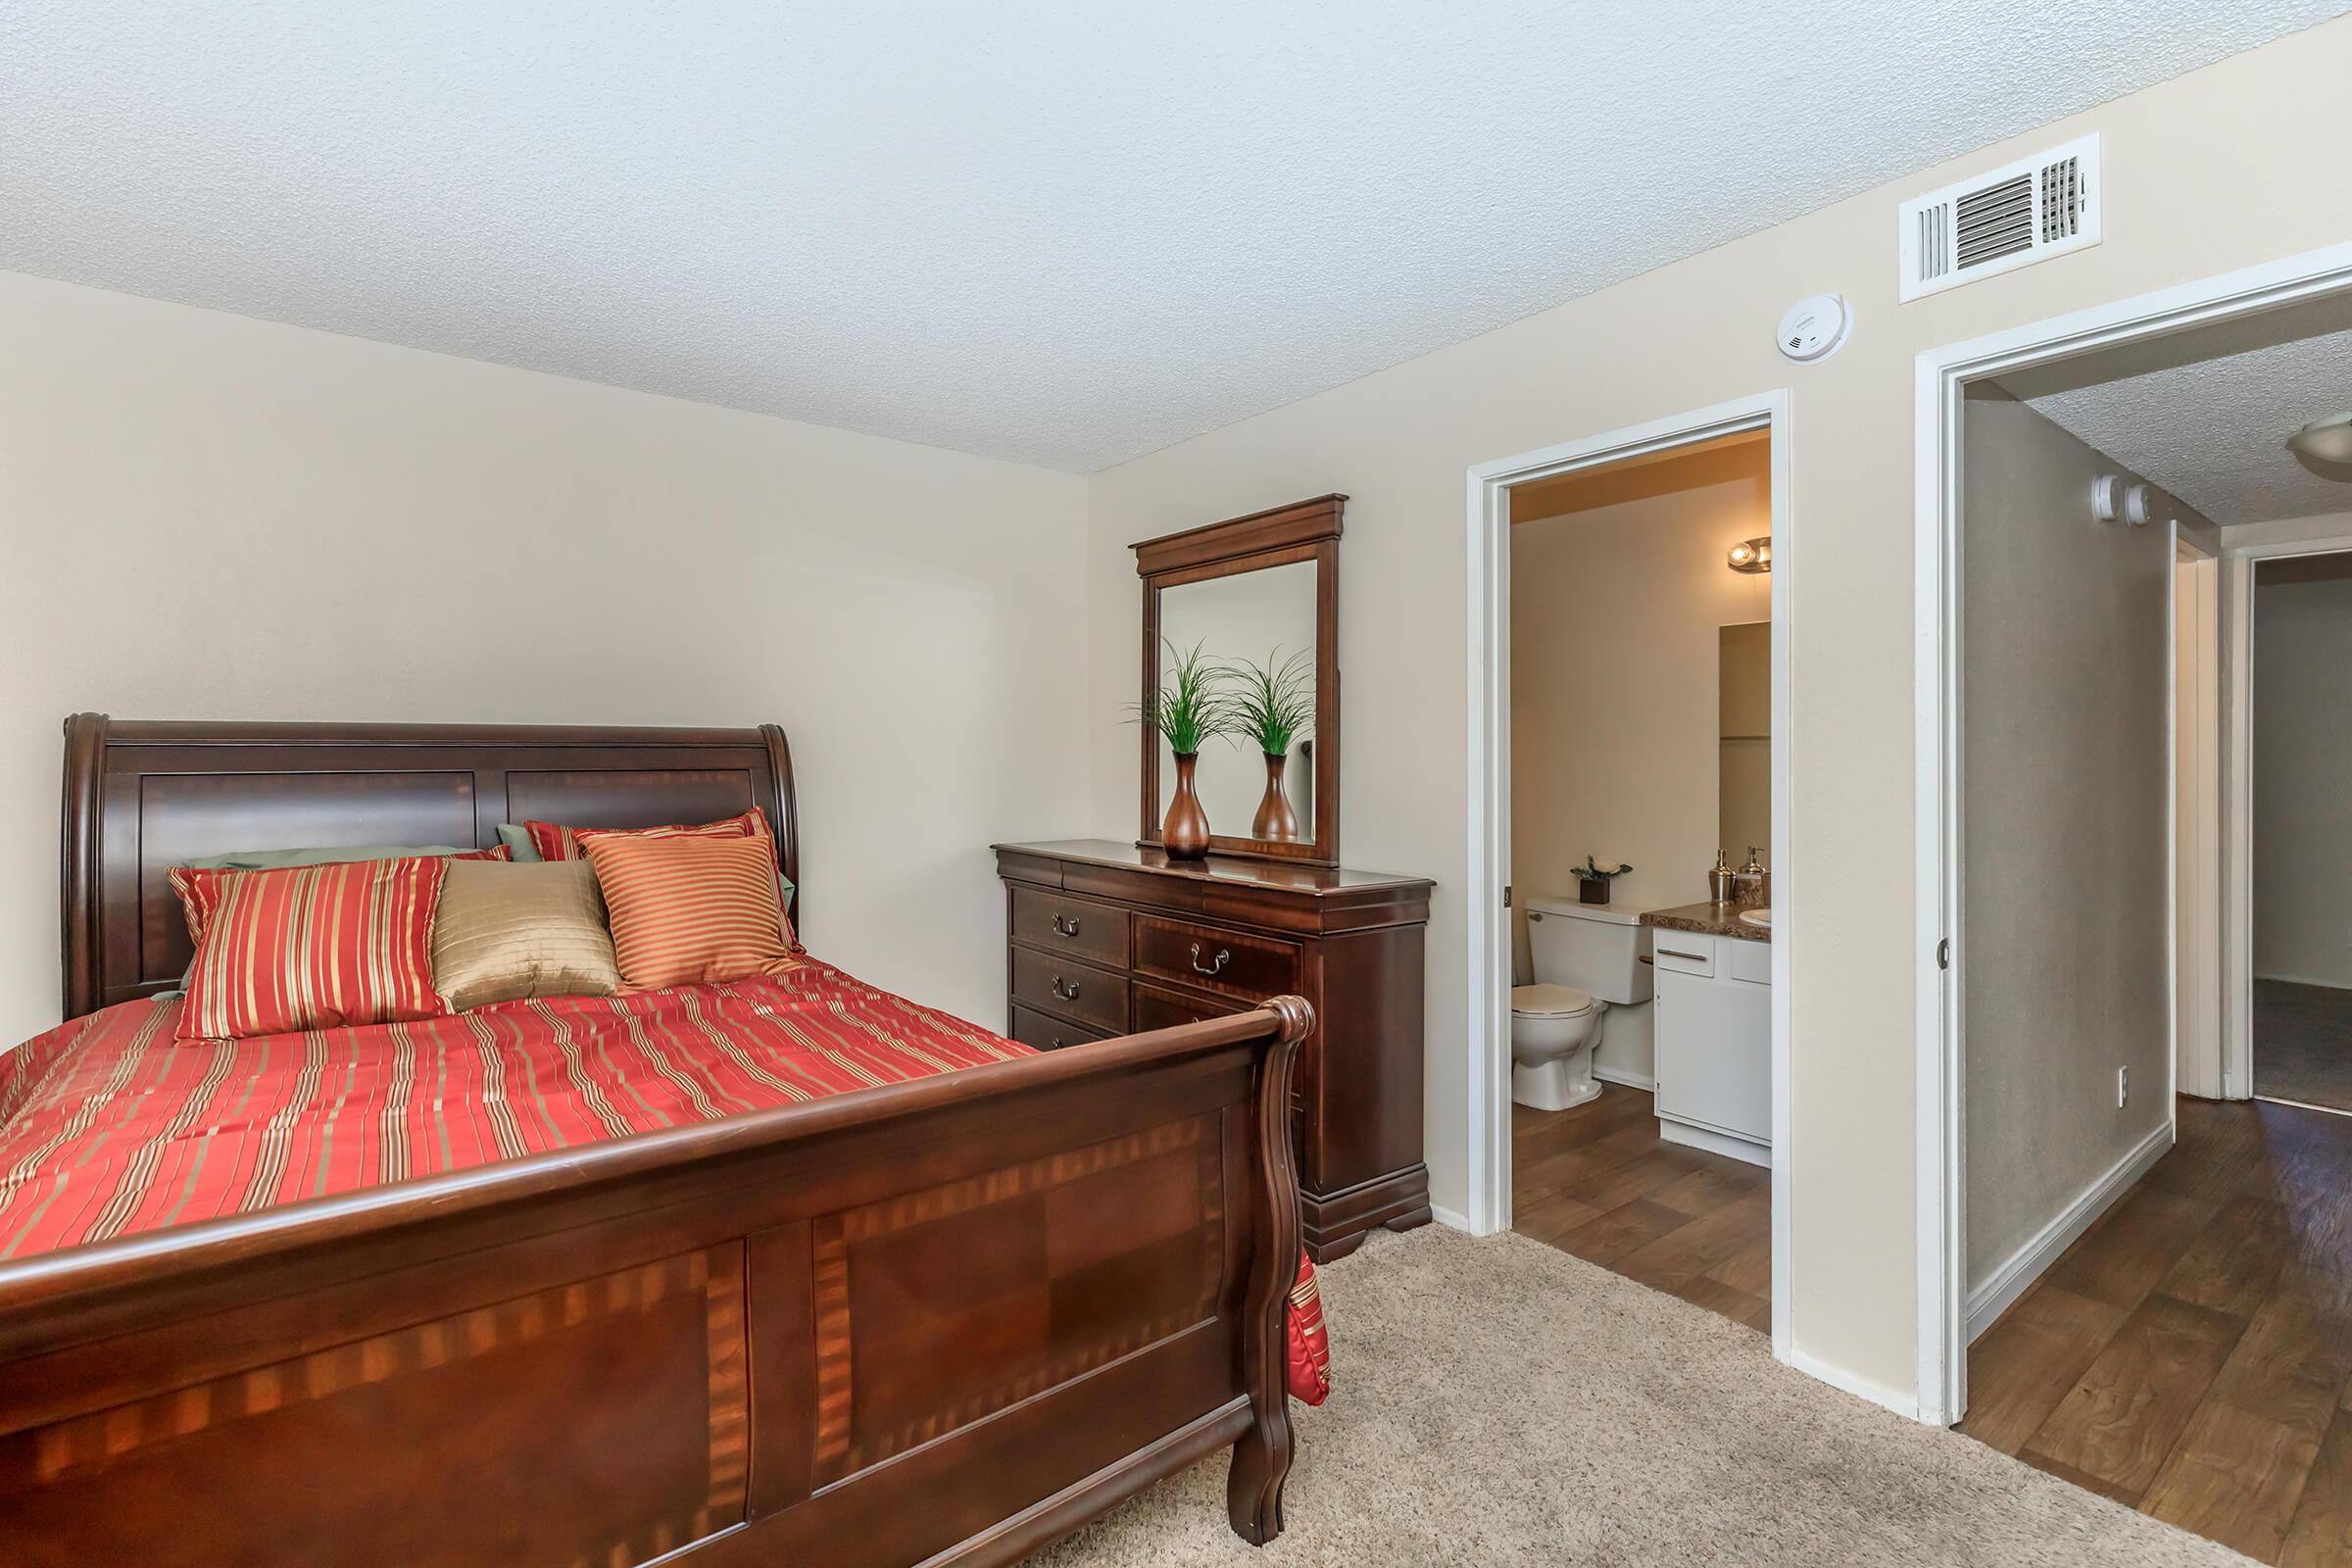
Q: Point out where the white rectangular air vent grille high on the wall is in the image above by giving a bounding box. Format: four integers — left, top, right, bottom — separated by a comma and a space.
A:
1900, 136, 2098, 299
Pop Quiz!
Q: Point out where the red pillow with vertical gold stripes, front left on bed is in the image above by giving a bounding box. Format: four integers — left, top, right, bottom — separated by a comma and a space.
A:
172, 856, 449, 1039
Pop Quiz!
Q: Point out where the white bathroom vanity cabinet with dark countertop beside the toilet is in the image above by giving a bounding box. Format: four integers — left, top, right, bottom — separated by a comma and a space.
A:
1642, 903, 1771, 1166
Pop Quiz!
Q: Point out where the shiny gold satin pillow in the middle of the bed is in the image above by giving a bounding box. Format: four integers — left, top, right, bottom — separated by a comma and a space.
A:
433, 860, 621, 1013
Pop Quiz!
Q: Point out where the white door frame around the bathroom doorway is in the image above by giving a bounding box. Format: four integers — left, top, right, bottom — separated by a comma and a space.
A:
1463, 388, 1801, 1361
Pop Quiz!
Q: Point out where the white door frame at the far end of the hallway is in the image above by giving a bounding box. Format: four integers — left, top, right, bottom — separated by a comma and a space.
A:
2221, 519, 2352, 1101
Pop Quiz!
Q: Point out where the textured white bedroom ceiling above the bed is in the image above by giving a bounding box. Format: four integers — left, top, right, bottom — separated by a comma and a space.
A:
0, 0, 2352, 470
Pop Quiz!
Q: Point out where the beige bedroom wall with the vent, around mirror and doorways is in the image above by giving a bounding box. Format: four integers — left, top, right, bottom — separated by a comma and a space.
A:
1087, 22, 2352, 1398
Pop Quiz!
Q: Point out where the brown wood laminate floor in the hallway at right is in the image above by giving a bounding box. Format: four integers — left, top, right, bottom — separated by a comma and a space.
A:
1959, 1101, 2352, 1568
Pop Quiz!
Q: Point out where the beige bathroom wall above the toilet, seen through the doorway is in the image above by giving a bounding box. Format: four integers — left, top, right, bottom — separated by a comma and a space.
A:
1505, 453, 1771, 945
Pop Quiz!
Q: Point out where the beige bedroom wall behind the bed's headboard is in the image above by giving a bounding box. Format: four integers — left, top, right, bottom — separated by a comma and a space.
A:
0, 275, 1082, 1044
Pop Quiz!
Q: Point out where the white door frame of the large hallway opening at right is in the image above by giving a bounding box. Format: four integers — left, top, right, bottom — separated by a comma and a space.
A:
1912, 244, 2352, 1425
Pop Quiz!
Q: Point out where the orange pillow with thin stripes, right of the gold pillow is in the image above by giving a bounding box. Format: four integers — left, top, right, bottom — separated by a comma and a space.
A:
581, 832, 795, 990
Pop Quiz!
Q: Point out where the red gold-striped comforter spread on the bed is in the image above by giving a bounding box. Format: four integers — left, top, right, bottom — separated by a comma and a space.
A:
0, 956, 1329, 1403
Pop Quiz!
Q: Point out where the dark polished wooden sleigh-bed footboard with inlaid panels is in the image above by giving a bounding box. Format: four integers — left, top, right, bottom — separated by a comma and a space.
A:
0, 997, 1307, 1568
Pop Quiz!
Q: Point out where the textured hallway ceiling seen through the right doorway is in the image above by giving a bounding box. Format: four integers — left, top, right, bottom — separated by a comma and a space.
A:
2004, 299, 2352, 526
